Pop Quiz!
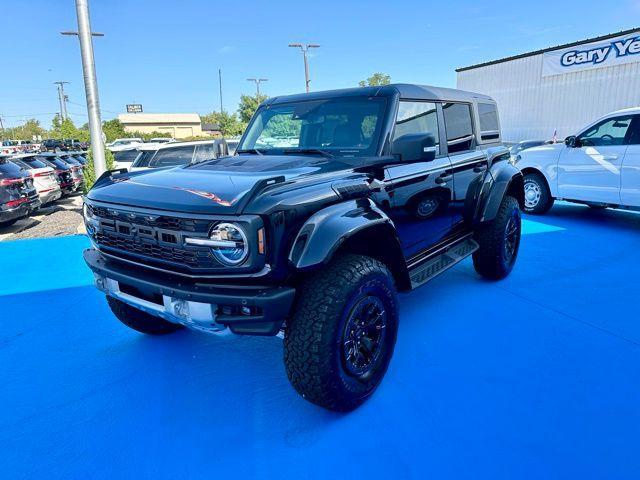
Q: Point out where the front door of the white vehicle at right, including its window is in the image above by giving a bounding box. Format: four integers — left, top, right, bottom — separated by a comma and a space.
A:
558, 115, 631, 204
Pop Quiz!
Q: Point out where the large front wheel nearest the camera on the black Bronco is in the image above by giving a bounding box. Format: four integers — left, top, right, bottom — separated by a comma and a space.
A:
284, 254, 398, 411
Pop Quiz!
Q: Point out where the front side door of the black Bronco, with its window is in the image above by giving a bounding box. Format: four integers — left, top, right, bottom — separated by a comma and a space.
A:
385, 100, 453, 259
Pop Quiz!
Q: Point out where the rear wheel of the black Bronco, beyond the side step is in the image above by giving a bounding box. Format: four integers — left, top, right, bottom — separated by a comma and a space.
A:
473, 195, 521, 280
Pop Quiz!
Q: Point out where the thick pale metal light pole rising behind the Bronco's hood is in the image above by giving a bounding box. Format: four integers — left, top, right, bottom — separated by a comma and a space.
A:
62, 0, 107, 178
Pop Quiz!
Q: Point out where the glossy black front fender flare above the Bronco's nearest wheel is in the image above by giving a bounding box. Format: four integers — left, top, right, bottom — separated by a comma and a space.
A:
288, 198, 400, 270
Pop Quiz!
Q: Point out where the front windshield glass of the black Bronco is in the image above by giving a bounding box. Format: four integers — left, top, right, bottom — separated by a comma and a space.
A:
238, 97, 387, 157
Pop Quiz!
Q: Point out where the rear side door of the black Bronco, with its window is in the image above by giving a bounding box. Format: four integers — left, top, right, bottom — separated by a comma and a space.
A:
442, 102, 490, 224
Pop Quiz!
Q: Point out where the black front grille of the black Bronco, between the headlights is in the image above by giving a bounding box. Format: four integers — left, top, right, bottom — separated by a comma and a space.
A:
88, 205, 223, 271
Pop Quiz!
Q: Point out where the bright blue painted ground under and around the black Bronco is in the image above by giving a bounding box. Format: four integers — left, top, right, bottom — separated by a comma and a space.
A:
0, 205, 640, 479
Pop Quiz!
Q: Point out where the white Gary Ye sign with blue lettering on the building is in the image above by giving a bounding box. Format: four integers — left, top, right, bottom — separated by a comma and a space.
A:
542, 34, 640, 77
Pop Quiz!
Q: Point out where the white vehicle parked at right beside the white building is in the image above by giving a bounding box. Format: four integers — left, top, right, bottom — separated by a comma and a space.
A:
515, 107, 640, 214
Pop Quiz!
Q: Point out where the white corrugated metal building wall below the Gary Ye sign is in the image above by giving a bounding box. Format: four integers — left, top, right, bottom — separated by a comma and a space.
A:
457, 54, 640, 142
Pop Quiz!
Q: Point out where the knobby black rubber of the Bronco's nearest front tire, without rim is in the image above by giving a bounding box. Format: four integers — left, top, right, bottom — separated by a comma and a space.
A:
284, 254, 398, 411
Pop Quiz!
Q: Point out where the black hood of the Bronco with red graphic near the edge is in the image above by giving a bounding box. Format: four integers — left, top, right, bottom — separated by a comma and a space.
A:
87, 155, 351, 214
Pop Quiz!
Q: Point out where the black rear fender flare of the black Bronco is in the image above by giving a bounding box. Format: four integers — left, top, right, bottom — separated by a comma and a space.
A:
474, 161, 524, 223
